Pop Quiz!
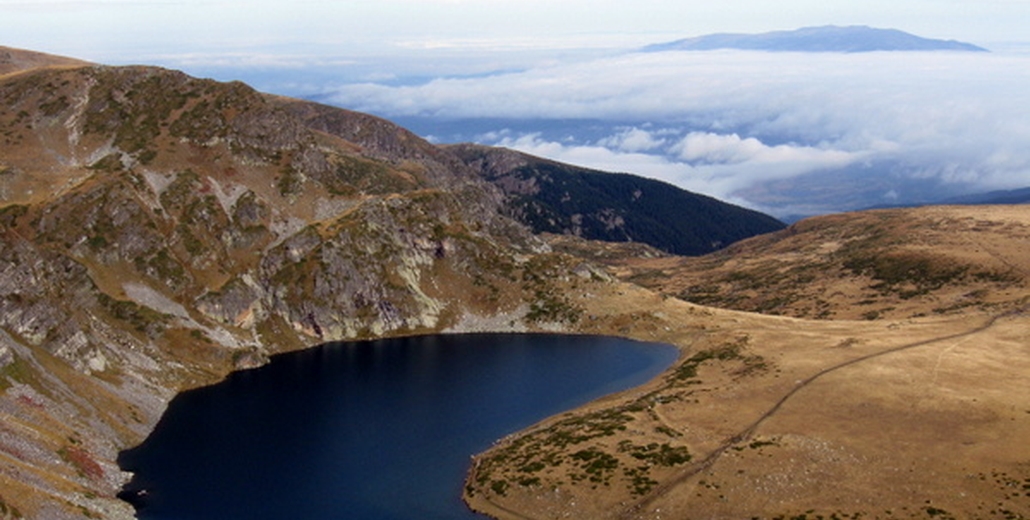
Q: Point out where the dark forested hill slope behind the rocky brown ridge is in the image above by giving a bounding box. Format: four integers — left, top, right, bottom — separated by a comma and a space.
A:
446, 144, 784, 255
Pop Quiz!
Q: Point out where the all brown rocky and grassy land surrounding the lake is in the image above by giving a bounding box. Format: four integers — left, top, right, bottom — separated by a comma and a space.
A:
0, 45, 1030, 519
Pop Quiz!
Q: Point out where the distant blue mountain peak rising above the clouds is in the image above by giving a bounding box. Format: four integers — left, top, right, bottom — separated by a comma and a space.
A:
643, 26, 988, 53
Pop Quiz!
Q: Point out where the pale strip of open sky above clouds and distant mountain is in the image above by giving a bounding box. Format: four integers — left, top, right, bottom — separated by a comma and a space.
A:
0, 0, 1030, 63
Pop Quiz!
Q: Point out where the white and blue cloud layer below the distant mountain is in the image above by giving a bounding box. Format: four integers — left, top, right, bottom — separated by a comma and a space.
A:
330, 51, 1030, 213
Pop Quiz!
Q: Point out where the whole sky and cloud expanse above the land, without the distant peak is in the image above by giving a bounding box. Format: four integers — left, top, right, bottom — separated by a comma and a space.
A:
0, 0, 1030, 217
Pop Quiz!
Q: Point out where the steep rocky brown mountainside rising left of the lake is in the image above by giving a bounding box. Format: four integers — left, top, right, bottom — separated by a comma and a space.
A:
0, 59, 593, 518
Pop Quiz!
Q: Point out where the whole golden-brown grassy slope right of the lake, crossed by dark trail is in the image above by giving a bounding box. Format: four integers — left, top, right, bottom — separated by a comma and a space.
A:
466, 206, 1030, 520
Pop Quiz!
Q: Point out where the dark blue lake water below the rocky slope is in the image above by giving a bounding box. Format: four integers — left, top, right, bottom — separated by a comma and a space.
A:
118, 335, 677, 520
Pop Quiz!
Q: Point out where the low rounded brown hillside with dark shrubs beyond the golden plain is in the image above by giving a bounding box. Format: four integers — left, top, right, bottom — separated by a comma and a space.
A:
609, 206, 1030, 319
